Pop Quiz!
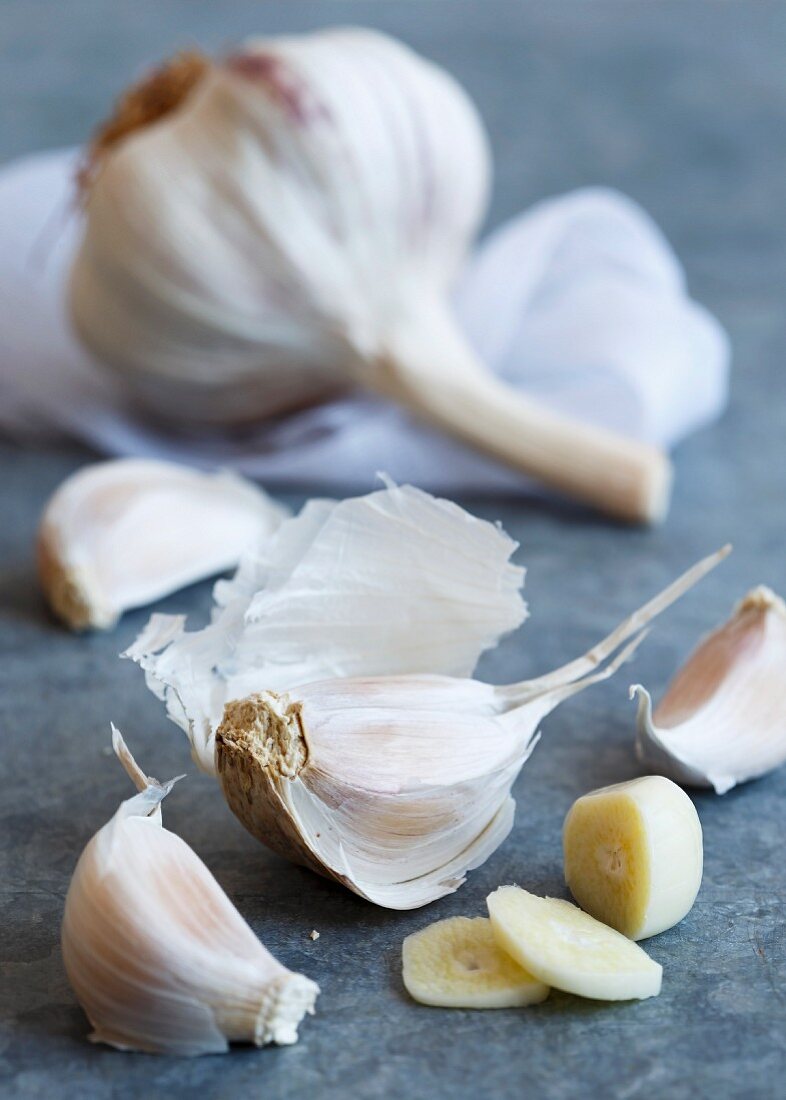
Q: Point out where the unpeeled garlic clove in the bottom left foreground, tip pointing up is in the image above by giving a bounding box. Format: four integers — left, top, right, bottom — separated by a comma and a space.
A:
62, 728, 319, 1055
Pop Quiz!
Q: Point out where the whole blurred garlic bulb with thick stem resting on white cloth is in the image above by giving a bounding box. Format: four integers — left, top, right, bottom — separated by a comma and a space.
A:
70, 30, 671, 521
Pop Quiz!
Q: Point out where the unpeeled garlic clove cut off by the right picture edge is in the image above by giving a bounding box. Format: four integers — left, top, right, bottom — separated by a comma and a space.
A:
631, 586, 786, 794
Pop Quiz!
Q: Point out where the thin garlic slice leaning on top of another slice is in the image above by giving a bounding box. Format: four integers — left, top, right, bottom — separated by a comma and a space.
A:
486, 887, 663, 1001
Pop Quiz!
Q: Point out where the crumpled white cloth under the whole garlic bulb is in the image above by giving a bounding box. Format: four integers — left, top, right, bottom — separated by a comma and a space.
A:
0, 151, 729, 493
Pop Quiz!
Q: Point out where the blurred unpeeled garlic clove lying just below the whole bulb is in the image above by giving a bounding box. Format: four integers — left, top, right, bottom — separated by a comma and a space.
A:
38, 459, 286, 630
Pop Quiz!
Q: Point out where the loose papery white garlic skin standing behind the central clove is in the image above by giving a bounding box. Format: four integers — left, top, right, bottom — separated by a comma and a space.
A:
124, 484, 527, 773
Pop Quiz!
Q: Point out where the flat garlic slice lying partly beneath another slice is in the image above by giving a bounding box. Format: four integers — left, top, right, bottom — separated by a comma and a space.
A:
401, 916, 549, 1009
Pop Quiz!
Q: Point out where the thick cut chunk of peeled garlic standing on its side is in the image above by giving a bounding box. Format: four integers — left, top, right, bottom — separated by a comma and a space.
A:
563, 776, 704, 939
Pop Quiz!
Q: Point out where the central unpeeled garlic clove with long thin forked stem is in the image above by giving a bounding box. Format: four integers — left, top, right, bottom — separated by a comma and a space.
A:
215, 551, 724, 909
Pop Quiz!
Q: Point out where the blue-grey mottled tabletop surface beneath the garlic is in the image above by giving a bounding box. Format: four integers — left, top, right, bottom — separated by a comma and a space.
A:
0, 0, 786, 1100
